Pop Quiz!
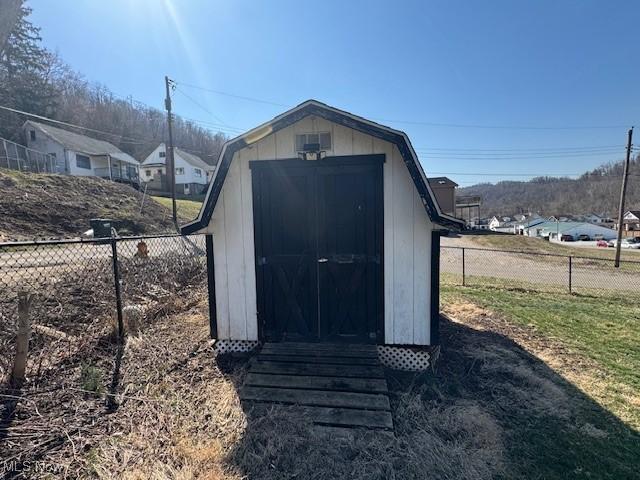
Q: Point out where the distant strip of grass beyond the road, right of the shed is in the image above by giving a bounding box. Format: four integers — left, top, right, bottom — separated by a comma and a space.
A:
463, 234, 640, 261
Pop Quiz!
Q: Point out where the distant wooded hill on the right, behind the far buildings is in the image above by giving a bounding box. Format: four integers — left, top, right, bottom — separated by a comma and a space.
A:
458, 157, 640, 215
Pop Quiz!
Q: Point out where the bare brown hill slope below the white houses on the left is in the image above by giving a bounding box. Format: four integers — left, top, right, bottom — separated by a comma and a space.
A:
0, 170, 182, 240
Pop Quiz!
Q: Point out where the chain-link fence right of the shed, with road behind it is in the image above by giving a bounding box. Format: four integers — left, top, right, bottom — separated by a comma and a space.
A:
440, 246, 640, 296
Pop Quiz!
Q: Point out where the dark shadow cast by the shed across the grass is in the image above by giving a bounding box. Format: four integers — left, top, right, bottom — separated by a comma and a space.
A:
225, 318, 640, 480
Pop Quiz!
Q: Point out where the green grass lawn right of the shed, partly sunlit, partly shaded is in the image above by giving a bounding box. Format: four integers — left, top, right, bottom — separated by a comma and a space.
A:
441, 283, 640, 479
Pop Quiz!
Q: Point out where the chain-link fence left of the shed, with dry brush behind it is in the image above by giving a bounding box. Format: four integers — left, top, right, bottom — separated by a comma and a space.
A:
0, 235, 207, 384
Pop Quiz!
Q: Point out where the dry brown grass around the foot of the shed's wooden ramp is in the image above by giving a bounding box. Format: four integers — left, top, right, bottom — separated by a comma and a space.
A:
86, 304, 503, 480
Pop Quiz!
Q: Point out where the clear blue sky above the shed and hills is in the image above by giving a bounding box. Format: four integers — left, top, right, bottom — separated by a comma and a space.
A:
29, 0, 640, 186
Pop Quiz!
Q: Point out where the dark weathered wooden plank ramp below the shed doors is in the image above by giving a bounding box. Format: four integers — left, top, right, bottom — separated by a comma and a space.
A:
239, 342, 393, 430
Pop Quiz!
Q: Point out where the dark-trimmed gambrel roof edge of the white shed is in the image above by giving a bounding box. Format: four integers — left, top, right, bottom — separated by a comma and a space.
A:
181, 100, 464, 234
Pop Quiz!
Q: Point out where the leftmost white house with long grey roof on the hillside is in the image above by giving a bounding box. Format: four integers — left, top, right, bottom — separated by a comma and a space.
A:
22, 120, 139, 186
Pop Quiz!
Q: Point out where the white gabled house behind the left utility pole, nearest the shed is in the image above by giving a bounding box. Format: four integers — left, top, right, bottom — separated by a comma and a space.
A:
140, 143, 215, 195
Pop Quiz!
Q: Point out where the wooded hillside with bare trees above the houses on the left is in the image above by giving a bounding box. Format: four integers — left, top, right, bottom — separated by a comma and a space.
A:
0, 4, 225, 164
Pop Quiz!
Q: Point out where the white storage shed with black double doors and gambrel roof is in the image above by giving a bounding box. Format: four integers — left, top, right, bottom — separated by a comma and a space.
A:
182, 100, 462, 356
